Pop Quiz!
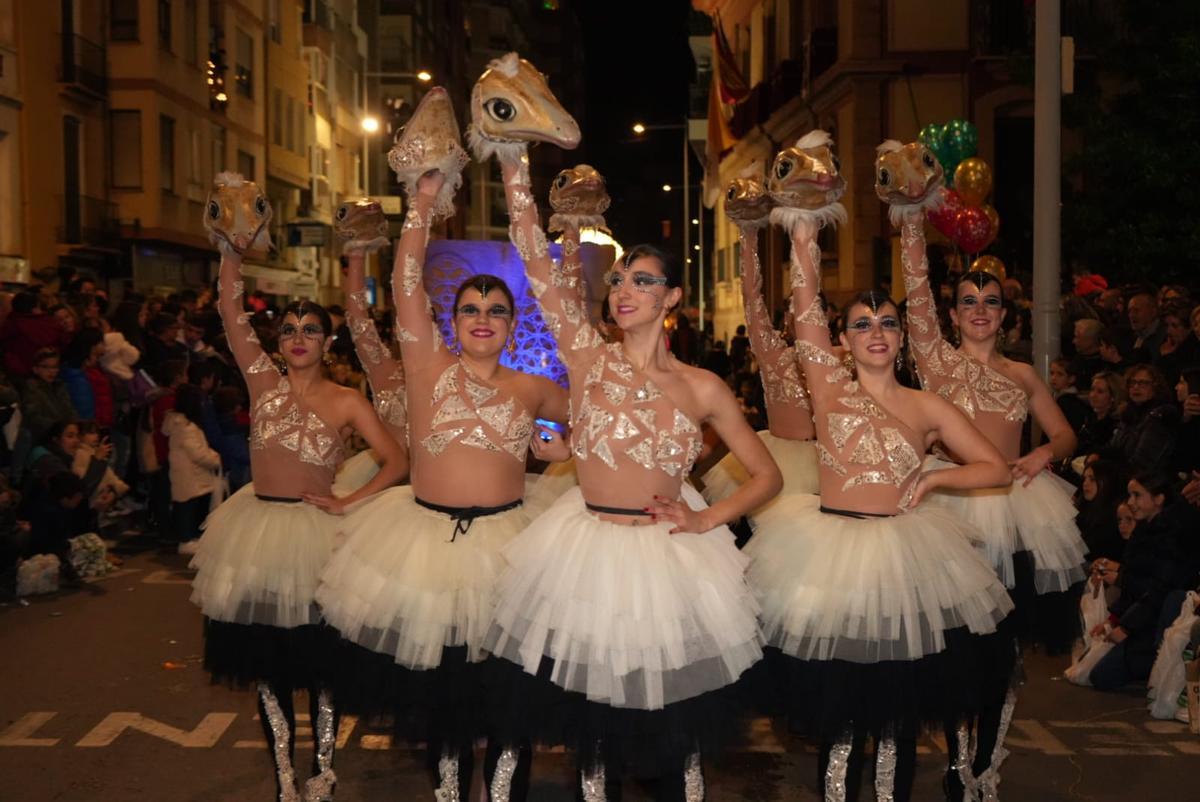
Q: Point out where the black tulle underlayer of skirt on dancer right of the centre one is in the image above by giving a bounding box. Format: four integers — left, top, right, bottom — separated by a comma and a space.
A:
748, 616, 1016, 738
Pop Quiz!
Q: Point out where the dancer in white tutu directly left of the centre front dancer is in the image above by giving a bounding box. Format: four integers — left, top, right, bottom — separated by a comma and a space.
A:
317, 88, 566, 801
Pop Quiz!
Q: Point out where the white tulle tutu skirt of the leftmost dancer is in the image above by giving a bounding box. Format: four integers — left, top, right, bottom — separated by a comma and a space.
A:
191, 484, 342, 628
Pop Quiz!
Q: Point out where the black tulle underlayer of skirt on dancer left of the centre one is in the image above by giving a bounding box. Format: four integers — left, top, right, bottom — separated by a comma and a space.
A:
334, 640, 487, 747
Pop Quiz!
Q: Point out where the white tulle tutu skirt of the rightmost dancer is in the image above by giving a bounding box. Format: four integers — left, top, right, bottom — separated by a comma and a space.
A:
925, 456, 1087, 594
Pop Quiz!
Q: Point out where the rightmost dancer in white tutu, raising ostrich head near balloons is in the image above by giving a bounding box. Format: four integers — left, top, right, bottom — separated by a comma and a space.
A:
876, 140, 1087, 800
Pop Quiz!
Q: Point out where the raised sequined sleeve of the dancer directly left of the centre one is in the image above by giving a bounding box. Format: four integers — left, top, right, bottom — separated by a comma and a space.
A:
391, 188, 444, 365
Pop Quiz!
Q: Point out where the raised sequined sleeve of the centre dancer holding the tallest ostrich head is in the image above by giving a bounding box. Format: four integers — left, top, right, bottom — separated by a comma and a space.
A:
500, 154, 604, 364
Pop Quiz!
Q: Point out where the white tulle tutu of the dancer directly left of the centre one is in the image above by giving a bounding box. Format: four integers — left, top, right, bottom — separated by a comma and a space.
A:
317, 486, 528, 670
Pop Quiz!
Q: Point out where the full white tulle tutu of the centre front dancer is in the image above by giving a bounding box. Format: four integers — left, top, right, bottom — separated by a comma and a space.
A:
485, 486, 762, 711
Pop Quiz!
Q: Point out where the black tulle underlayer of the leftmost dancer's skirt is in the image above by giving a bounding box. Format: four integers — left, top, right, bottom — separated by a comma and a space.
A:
204, 618, 338, 688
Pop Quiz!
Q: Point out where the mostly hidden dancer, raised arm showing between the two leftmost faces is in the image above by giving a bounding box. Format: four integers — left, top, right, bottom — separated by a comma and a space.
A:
334, 198, 408, 496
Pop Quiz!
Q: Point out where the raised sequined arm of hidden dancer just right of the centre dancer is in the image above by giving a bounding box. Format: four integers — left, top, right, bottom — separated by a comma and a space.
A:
738, 228, 810, 409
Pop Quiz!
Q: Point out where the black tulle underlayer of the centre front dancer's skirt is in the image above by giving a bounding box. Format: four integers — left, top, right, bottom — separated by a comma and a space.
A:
484, 658, 749, 777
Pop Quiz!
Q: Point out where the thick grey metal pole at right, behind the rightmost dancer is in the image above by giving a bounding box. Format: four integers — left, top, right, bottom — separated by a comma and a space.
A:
1033, 2, 1062, 379
